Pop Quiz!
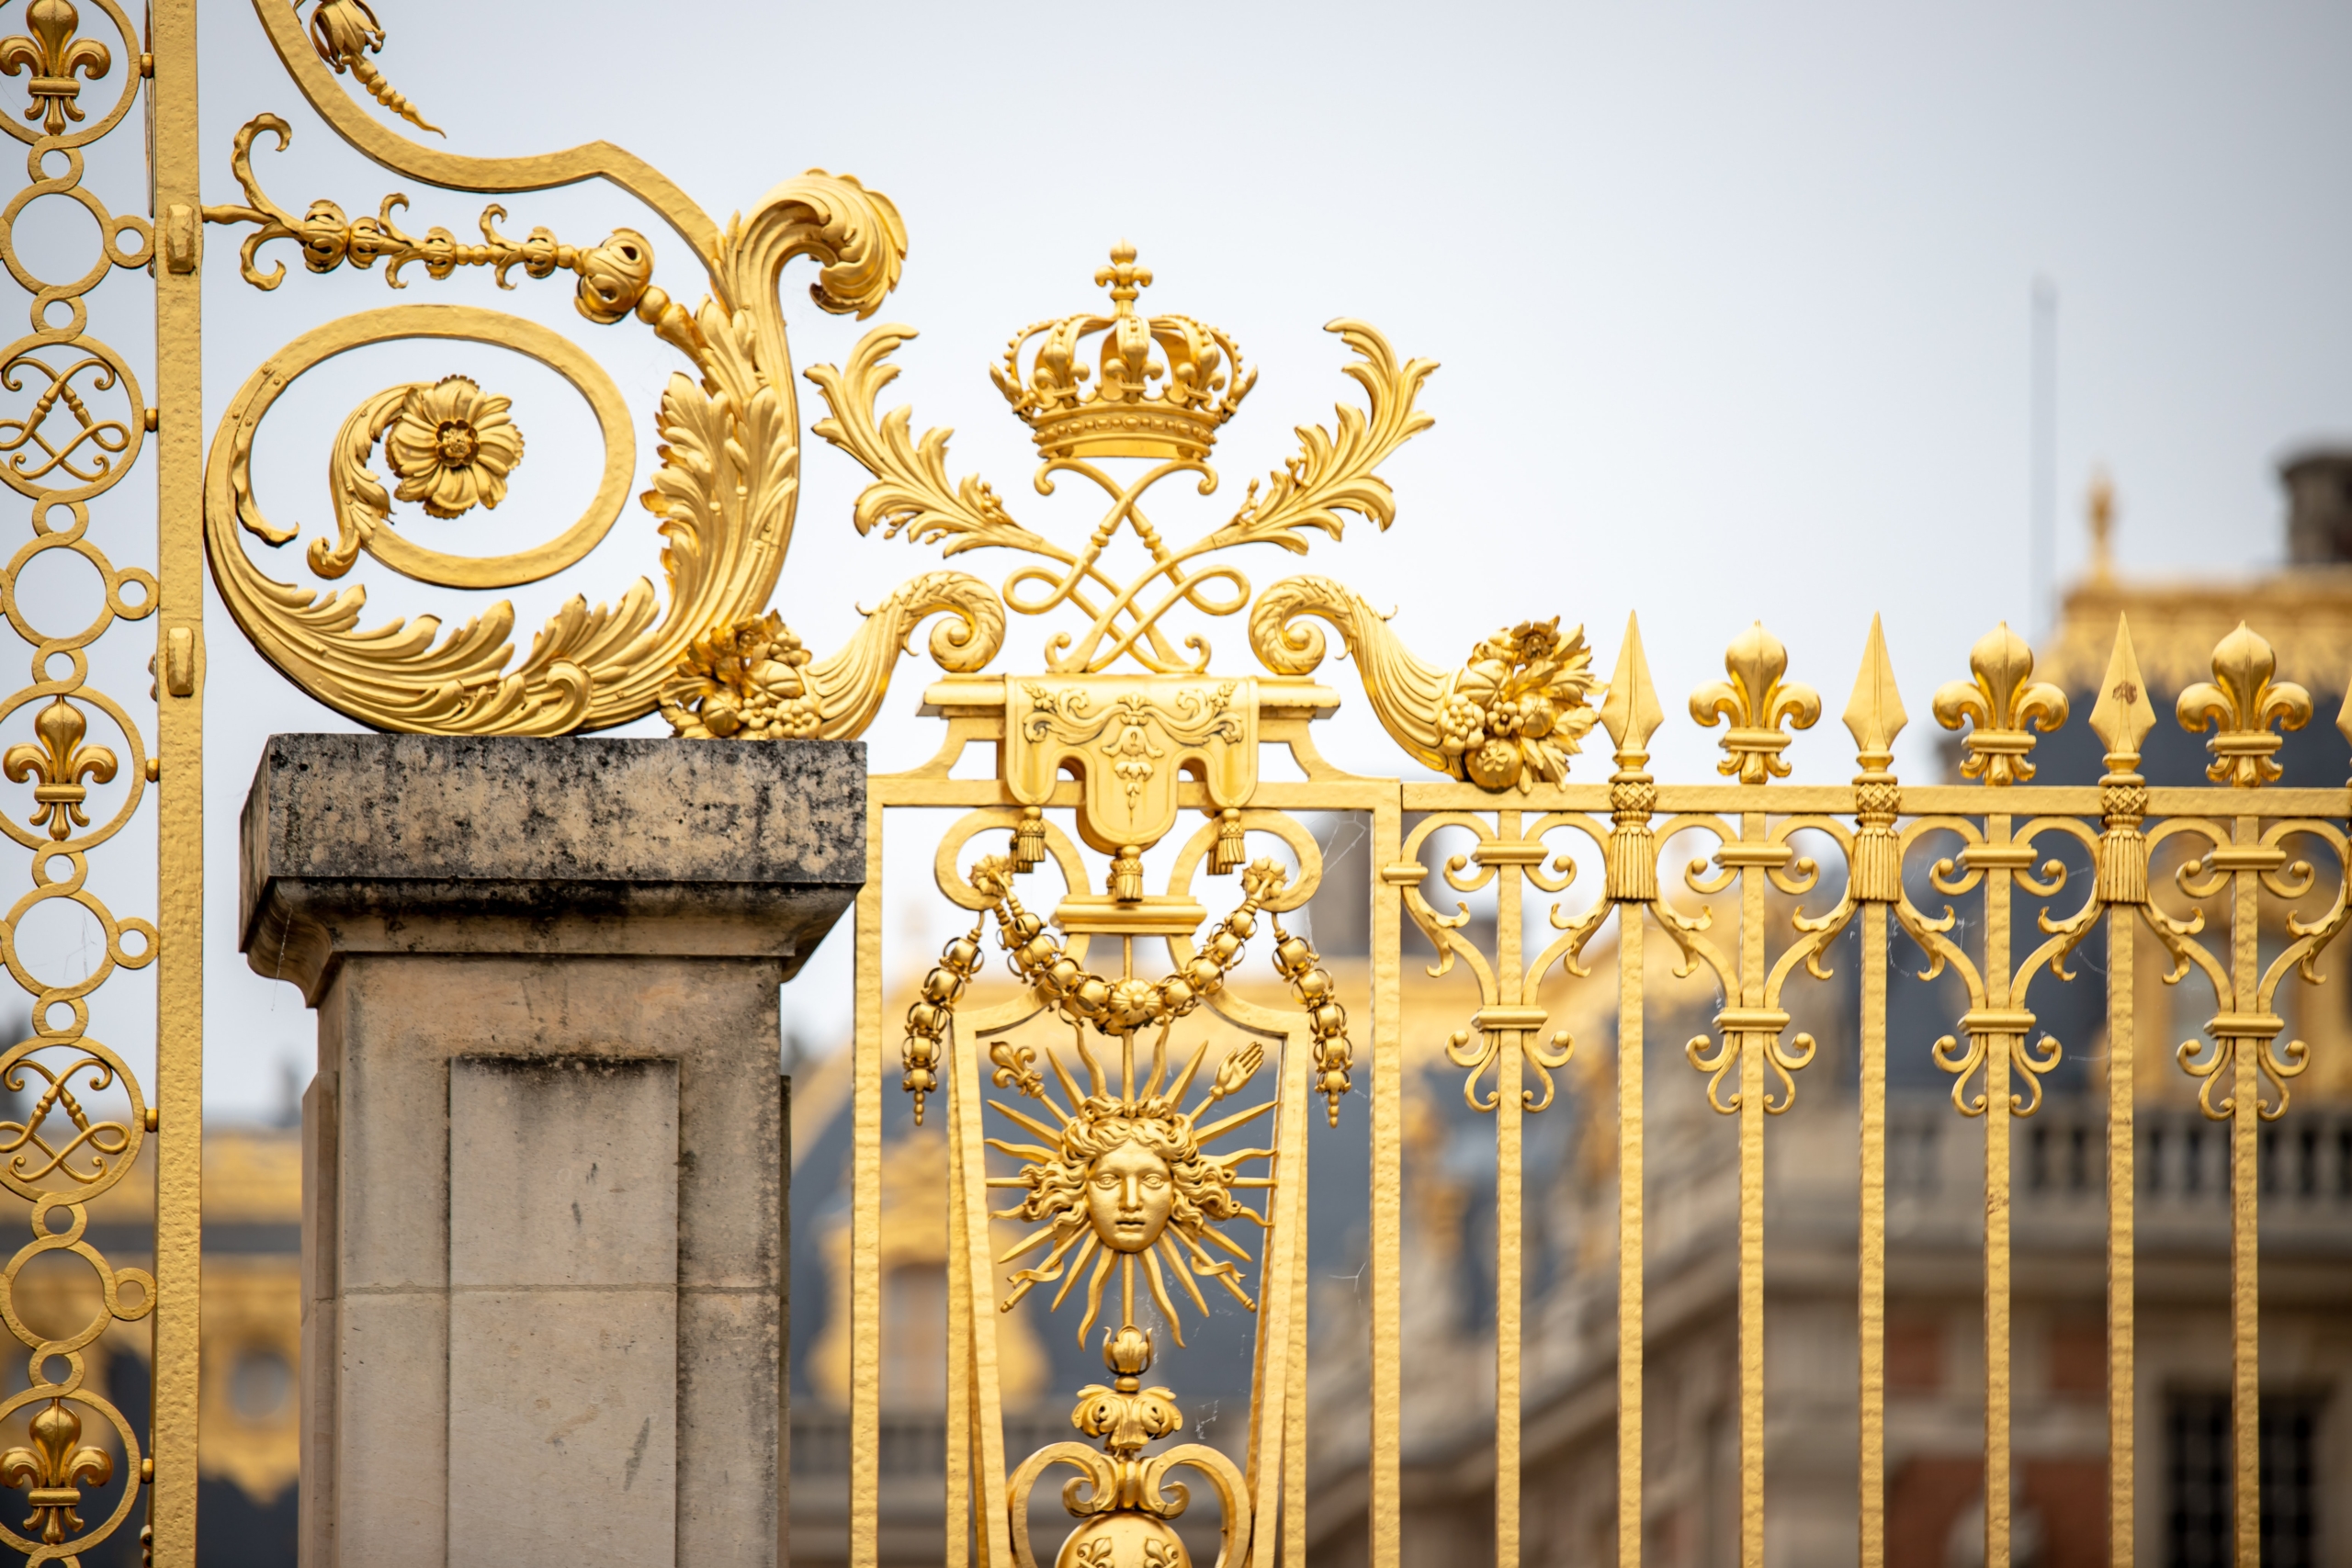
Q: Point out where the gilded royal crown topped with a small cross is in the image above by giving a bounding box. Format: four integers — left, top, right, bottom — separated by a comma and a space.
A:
990, 240, 1259, 461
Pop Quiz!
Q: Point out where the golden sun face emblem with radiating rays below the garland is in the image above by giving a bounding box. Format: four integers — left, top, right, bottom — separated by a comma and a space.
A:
988, 1032, 1275, 1345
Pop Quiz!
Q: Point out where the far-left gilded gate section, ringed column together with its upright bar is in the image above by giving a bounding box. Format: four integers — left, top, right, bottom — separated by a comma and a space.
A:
0, 0, 202, 1563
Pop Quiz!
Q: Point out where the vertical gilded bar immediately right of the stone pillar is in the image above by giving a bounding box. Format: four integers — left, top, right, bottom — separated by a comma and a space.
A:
849, 808, 887, 1568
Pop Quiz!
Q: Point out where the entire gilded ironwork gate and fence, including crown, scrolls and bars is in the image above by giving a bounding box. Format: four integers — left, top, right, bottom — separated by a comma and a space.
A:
0, 0, 2352, 1568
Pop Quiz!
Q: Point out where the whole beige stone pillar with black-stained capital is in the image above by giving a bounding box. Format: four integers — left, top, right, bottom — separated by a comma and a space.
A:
240, 736, 865, 1568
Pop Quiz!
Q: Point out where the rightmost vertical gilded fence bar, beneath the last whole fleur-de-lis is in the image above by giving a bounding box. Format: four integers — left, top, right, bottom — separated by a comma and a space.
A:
2227, 816, 2267, 1568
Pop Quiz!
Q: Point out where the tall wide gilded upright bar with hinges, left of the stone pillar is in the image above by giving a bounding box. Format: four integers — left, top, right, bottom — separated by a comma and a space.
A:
152, 0, 205, 1568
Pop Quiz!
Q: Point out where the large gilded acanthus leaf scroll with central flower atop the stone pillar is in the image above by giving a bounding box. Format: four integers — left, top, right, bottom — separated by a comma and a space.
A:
205, 92, 1002, 736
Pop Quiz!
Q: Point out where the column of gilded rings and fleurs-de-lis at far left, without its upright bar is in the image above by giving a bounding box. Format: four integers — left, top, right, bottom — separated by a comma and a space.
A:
0, 0, 171, 1563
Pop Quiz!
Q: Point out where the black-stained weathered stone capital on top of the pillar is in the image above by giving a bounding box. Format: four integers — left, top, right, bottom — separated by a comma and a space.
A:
238, 733, 865, 1006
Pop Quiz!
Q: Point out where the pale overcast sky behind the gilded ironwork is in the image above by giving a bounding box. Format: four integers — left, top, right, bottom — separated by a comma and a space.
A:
141, 0, 2352, 1114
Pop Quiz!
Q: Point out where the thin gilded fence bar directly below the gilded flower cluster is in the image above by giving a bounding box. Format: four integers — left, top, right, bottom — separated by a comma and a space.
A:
1494, 811, 1524, 1568
